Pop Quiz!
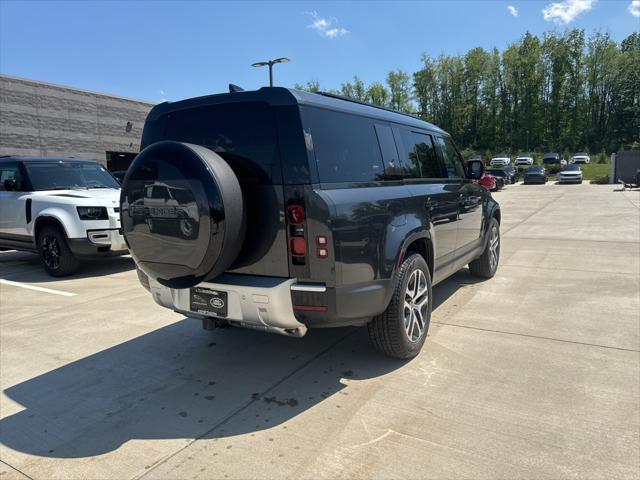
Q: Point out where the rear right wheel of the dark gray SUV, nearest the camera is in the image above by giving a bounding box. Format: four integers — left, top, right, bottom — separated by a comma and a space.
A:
367, 254, 433, 359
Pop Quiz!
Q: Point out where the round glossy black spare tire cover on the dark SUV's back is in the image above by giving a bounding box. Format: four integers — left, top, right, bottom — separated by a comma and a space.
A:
120, 141, 245, 288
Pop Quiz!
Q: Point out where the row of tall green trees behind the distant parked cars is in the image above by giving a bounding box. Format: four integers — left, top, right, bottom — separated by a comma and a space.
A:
295, 29, 640, 157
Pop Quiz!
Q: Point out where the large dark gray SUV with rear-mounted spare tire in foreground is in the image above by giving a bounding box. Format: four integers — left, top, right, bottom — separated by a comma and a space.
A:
121, 88, 500, 358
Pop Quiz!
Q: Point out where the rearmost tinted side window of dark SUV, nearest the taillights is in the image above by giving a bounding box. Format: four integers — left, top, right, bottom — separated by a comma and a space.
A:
300, 107, 384, 183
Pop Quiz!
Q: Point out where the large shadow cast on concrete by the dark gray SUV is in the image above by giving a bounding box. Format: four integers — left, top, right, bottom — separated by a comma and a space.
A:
0, 270, 475, 458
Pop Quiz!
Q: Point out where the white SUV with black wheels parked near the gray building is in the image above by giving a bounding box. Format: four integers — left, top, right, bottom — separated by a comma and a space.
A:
0, 157, 127, 276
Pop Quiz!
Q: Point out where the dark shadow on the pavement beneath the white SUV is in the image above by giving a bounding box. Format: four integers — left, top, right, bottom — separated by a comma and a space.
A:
0, 250, 135, 283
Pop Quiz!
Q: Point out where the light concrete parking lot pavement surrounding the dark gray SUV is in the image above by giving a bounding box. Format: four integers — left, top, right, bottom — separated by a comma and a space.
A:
0, 184, 640, 480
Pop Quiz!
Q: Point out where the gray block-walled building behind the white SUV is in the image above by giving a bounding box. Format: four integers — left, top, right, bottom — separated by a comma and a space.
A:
0, 75, 153, 170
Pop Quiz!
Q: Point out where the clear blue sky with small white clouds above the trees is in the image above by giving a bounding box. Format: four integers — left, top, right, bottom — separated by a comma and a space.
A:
0, 0, 640, 102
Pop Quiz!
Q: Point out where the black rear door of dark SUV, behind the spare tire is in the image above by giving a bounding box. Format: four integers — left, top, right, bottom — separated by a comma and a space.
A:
142, 102, 289, 277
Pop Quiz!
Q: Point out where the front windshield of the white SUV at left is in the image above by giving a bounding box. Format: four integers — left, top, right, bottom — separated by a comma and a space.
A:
25, 161, 120, 191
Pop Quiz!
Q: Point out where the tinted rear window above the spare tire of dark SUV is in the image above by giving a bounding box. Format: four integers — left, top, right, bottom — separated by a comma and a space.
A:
144, 102, 282, 184
